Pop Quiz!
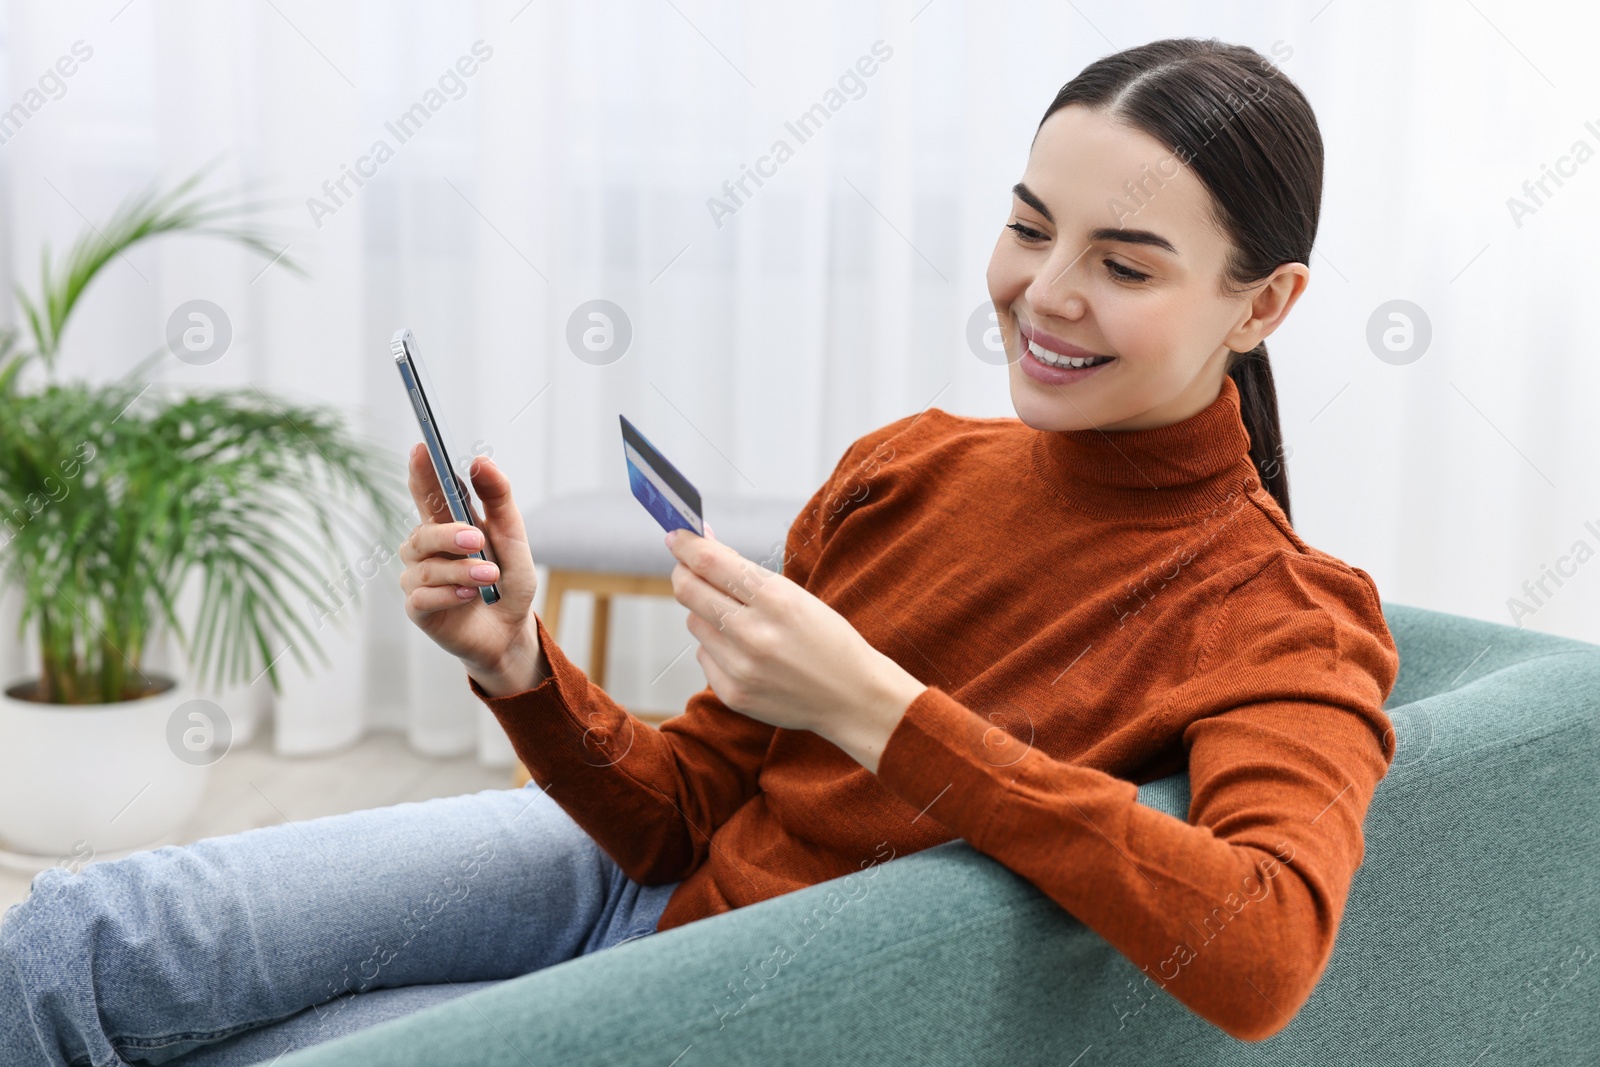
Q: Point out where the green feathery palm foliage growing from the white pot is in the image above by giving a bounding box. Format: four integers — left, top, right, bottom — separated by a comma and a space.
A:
0, 174, 406, 702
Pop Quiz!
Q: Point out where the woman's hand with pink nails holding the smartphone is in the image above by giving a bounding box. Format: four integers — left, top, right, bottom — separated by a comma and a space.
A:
400, 443, 549, 696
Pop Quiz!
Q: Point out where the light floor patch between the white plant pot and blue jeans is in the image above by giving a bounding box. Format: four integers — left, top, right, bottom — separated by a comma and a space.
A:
0, 731, 512, 913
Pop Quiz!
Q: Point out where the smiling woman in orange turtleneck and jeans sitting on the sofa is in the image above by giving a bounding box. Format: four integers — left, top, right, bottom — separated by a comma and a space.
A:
0, 40, 1397, 1064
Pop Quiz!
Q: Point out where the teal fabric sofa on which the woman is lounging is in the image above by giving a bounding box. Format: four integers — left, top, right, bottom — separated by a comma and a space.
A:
268, 605, 1600, 1067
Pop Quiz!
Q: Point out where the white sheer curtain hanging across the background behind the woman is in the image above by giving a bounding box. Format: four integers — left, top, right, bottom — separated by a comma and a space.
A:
0, 0, 1600, 760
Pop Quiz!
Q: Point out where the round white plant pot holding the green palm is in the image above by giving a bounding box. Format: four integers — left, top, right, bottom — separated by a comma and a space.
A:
0, 672, 214, 865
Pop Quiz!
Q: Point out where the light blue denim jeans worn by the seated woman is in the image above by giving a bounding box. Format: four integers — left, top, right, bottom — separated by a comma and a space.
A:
0, 784, 677, 1067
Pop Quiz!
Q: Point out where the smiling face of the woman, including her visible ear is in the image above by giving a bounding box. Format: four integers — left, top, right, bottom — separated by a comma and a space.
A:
989, 104, 1309, 430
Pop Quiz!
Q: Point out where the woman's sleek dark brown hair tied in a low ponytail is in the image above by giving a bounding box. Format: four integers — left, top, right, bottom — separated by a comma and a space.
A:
1038, 37, 1322, 515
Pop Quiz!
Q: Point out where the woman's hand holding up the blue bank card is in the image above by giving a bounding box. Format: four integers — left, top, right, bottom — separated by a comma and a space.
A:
667, 525, 926, 771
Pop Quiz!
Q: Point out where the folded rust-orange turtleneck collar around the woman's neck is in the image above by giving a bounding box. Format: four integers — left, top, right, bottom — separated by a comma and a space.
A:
1030, 376, 1259, 520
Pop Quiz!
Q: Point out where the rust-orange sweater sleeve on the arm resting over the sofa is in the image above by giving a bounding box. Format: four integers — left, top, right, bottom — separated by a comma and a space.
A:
878, 550, 1398, 1040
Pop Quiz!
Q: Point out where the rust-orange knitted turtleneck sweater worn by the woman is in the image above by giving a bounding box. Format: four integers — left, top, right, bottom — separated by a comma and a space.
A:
469, 371, 1398, 1040
